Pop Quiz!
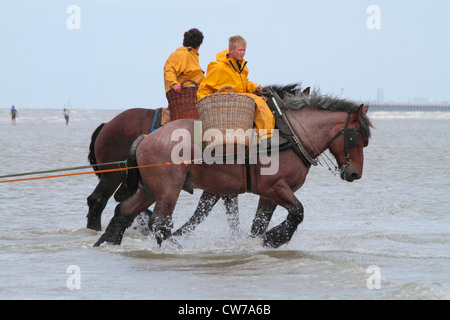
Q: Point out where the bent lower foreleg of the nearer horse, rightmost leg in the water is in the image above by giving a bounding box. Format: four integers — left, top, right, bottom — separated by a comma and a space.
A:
263, 200, 304, 248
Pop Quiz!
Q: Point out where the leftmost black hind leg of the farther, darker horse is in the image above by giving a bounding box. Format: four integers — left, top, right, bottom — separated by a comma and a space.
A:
86, 177, 121, 231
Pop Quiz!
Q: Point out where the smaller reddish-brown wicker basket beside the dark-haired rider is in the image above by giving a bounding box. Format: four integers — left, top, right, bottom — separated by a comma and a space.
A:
166, 79, 199, 121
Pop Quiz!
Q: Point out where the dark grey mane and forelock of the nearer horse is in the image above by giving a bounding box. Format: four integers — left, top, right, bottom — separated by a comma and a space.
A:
282, 89, 373, 139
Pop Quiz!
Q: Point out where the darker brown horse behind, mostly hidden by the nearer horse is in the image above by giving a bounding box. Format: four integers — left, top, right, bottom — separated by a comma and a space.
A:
87, 108, 239, 235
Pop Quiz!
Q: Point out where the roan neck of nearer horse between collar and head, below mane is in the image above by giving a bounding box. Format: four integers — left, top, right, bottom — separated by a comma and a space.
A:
286, 108, 347, 158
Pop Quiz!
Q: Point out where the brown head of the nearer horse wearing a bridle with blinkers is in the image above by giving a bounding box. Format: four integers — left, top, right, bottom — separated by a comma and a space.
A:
328, 105, 371, 182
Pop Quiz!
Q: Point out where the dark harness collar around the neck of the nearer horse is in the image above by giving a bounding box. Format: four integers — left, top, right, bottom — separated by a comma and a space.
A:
267, 87, 318, 167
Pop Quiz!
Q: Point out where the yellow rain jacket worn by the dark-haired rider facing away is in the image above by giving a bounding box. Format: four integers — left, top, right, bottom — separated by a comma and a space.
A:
164, 47, 205, 92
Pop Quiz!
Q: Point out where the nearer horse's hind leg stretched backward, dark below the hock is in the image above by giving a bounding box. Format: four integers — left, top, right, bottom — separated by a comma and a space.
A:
94, 189, 154, 247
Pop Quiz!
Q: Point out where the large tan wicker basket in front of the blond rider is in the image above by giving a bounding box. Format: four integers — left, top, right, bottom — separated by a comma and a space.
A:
198, 86, 255, 156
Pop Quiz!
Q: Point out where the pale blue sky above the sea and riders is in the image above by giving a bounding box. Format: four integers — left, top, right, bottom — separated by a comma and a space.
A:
0, 0, 450, 109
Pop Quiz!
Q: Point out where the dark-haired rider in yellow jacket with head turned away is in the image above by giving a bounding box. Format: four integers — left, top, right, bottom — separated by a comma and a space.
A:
164, 28, 205, 93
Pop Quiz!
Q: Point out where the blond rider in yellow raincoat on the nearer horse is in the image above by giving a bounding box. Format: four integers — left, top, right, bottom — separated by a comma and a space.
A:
197, 36, 275, 140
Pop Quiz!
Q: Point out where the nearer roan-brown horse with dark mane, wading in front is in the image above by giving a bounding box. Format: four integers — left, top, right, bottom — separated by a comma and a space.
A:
94, 87, 371, 247
